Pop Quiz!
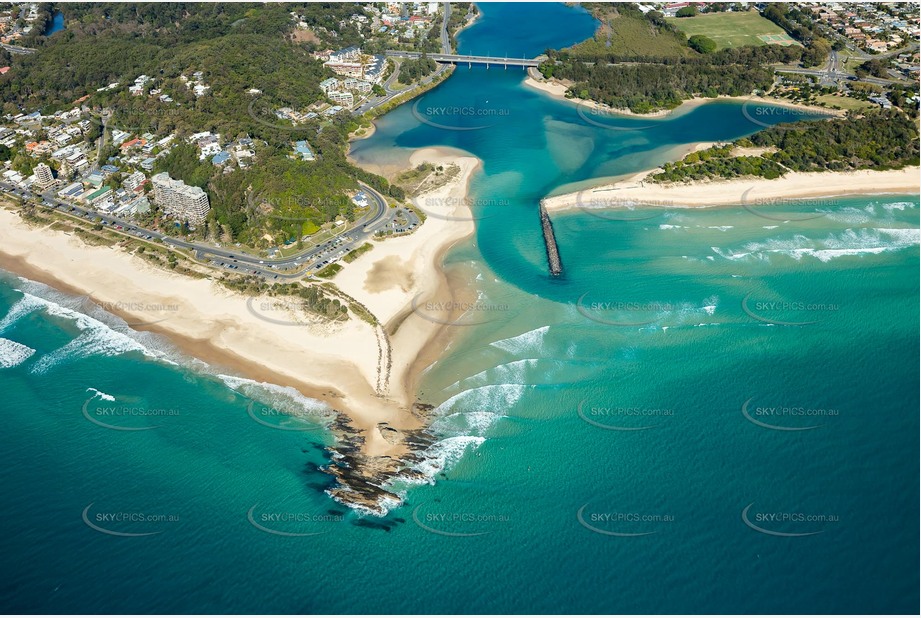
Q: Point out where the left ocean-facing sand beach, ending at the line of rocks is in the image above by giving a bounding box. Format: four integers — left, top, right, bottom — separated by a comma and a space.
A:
0, 209, 410, 455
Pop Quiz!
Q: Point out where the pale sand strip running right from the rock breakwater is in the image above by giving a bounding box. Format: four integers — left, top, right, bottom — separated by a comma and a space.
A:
542, 167, 919, 211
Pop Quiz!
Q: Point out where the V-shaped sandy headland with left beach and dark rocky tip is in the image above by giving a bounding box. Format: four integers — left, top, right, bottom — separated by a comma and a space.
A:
0, 149, 479, 514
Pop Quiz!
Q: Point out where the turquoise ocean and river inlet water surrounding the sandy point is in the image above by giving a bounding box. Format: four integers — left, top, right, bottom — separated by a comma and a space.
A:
0, 4, 919, 613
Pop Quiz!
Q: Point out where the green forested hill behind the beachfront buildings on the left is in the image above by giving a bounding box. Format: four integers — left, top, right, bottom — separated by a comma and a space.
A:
0, 3, 410, 246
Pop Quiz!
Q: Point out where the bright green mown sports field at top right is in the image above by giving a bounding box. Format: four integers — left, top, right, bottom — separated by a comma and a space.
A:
668, 11, 794, 49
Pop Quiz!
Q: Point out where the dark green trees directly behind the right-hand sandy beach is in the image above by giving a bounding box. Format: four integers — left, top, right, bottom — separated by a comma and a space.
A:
651, 110, 919, 182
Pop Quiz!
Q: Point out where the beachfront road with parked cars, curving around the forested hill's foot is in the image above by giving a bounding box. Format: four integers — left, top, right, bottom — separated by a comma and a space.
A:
0, 182, 395, 279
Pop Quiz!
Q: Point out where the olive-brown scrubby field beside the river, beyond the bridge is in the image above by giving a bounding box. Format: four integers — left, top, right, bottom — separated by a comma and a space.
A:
570, 5, 691, 57
